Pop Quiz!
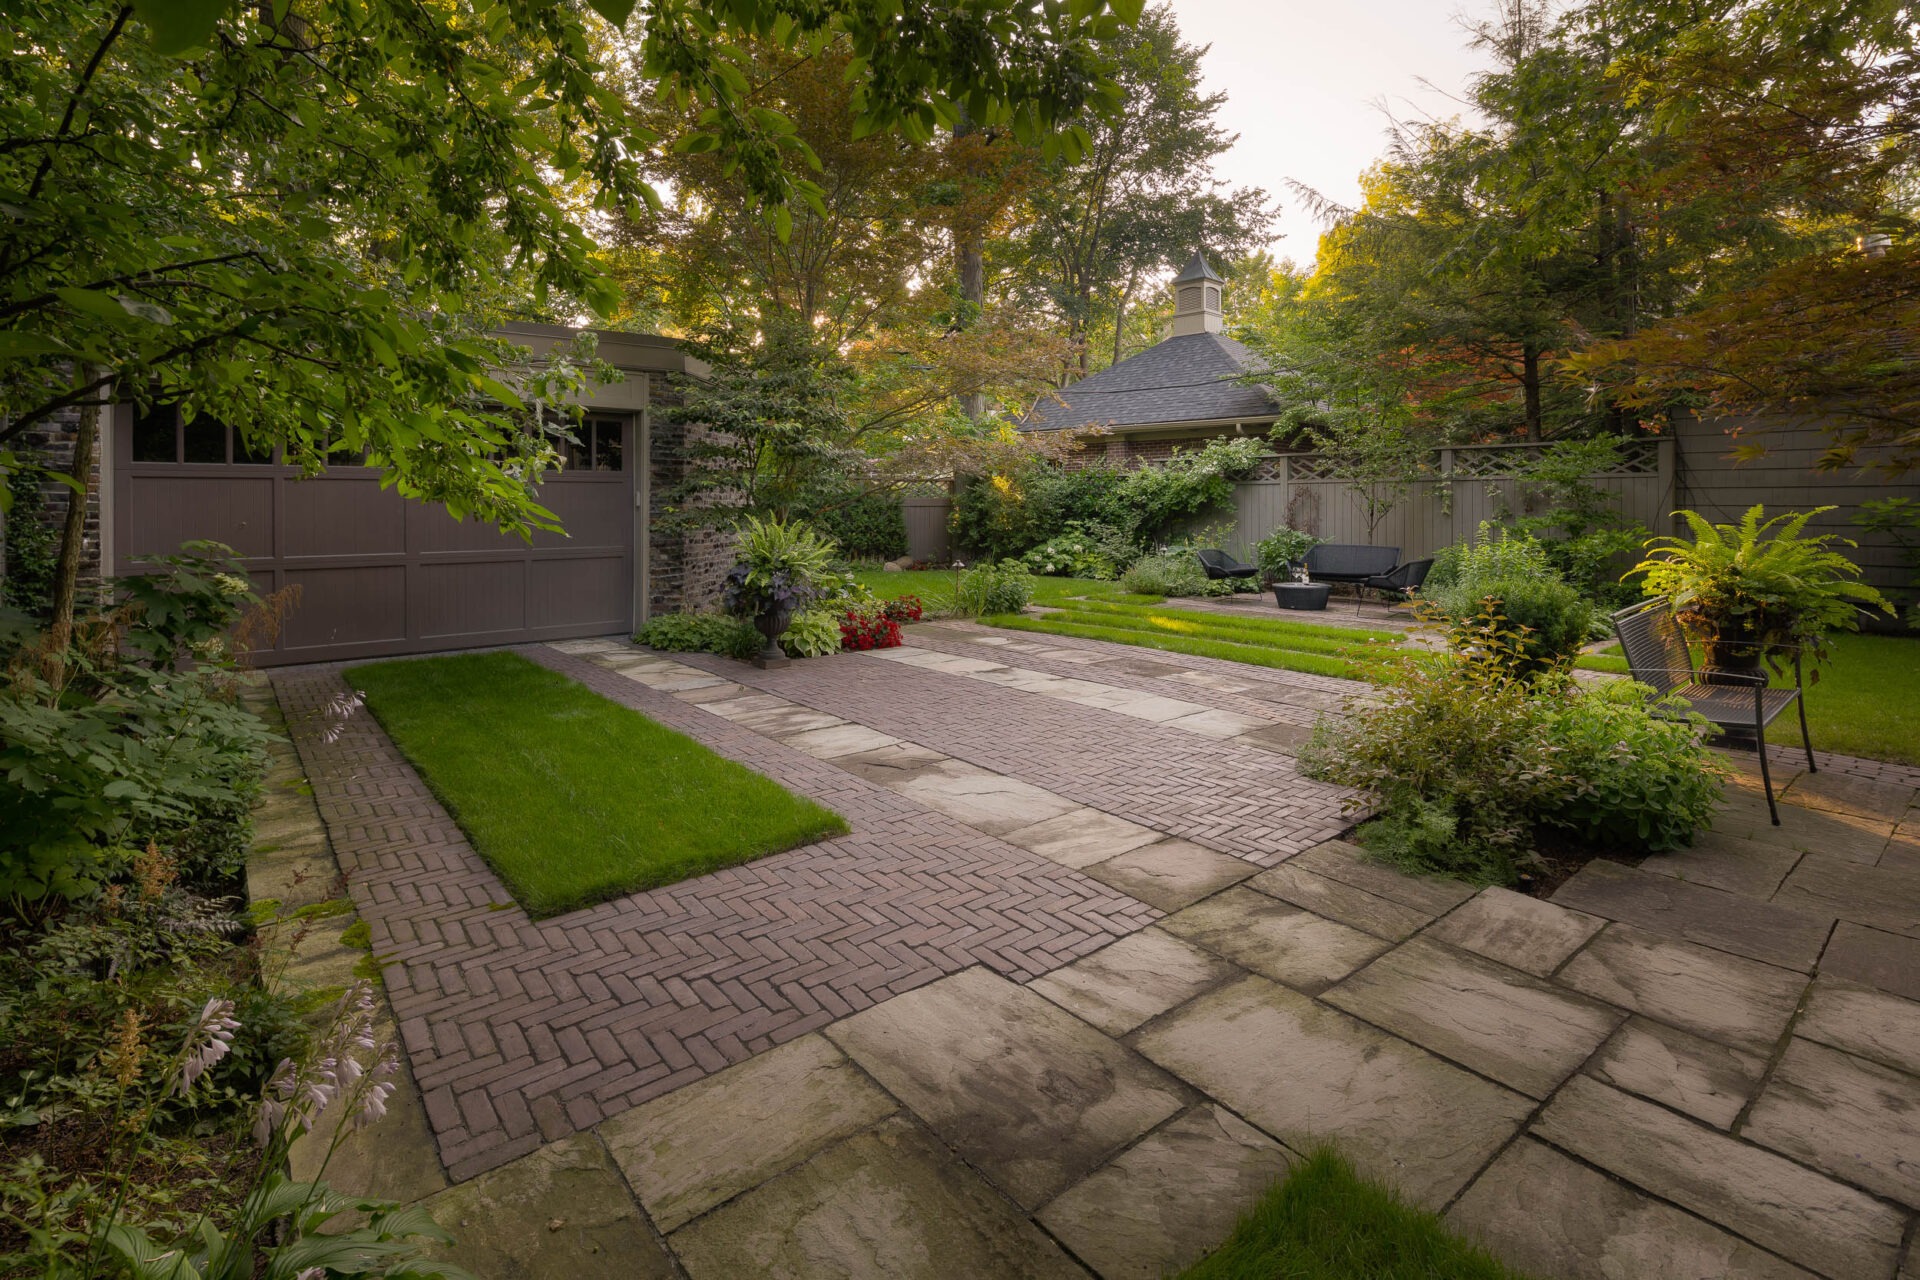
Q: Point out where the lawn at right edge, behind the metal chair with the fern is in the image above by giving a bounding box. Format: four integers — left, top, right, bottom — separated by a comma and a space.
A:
1580, 633, 1920, 764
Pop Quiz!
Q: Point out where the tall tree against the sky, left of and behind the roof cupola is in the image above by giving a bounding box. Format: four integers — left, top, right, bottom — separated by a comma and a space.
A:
1004, 4, 1273, 376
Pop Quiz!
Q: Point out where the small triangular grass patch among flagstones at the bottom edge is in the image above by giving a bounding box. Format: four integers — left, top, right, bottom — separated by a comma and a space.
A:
1181, 1151, 1524, 1280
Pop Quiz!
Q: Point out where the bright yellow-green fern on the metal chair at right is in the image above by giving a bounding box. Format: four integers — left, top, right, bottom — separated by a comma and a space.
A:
1632, 503, 1893, 672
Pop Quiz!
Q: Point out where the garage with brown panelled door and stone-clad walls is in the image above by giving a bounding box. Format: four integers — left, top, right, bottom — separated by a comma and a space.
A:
13, 324, 732, 666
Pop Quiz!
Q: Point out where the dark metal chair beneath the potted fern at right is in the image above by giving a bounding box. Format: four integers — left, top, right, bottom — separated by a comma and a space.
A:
1613, 599, 1820, 827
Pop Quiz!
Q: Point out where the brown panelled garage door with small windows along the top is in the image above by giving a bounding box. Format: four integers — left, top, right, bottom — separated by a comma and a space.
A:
113, 407, 639, 666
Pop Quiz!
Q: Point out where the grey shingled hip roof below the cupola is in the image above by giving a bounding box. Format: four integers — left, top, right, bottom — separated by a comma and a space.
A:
1020, 334, 1279, 432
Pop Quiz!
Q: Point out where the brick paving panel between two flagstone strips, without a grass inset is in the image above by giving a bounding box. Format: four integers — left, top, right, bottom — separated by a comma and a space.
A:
676, 640, 1354, 865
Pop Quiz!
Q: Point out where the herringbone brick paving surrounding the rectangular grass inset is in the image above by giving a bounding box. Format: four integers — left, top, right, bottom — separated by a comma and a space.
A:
273, 647, 1160, 1178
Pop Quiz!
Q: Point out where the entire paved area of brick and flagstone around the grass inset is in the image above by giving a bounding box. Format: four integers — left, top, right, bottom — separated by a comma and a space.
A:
261, 624, 1920, 1280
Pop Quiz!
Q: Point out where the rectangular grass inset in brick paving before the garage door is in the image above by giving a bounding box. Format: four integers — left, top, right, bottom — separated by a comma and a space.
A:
348, 652, 847, 917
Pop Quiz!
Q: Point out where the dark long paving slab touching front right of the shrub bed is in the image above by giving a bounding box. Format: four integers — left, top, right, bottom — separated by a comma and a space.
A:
1553, 858, 1834, 973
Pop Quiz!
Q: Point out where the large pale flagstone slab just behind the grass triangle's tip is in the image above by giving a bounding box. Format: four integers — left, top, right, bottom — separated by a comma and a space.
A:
1135, 977, 1534, 1209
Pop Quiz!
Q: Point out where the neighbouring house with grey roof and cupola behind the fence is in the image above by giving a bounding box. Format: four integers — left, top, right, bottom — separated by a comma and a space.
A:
1020, 251, 1279, 462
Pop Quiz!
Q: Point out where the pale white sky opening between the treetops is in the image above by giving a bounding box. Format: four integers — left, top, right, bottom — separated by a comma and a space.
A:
1173, 0, 1492, 263
